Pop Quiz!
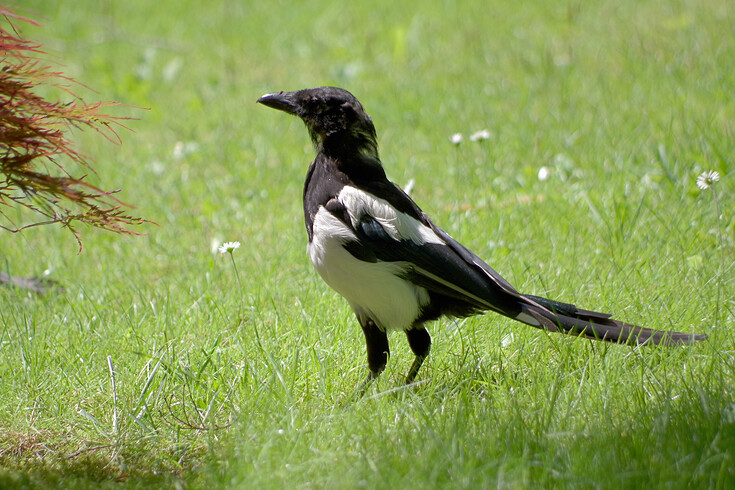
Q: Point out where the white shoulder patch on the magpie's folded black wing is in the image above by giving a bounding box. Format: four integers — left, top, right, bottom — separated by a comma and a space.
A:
337, 186, 446, 245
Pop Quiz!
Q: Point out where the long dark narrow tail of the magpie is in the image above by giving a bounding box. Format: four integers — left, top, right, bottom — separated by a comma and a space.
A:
518, 295, 707, 346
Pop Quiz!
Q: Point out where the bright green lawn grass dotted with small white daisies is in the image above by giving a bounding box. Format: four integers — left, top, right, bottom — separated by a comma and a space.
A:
0, 0, 735, 488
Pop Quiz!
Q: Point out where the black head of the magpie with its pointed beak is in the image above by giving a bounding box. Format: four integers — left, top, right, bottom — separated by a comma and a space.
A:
258, 87, 378, 158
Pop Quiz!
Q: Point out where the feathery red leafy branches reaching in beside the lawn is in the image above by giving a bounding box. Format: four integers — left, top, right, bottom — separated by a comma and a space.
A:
0, 6, 147, 251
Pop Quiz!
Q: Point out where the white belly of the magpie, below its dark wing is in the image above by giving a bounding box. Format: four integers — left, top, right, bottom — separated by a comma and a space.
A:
307, 208, 429, 330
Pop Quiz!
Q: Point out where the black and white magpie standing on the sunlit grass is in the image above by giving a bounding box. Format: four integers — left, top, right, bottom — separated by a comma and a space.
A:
257, 87, 706, 386
